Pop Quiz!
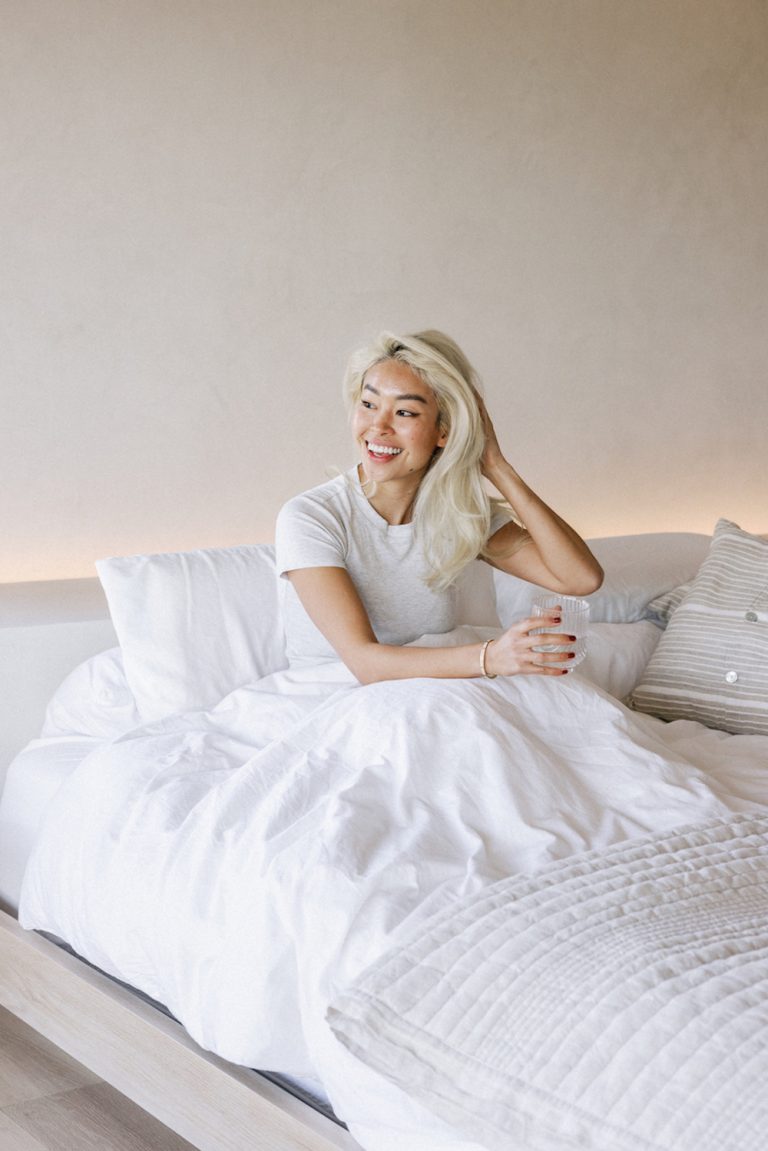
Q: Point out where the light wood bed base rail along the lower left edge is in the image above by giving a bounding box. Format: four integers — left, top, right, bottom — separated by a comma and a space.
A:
0, 912, 359, 1151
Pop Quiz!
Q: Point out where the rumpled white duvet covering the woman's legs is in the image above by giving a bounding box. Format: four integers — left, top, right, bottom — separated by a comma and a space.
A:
20, 663, 768, 1151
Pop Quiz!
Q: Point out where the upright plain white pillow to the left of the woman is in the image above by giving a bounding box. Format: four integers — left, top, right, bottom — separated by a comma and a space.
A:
96, 544, 286, 721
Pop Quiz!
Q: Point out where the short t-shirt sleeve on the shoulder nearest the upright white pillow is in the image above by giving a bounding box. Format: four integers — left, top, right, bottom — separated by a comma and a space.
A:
275, 494, 348, 576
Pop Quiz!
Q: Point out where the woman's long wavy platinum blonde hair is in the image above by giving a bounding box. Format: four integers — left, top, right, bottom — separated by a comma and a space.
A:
344, 330, 492, 590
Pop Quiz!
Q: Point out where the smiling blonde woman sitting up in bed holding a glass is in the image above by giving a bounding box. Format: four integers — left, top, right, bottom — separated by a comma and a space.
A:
276, 331, 602, 684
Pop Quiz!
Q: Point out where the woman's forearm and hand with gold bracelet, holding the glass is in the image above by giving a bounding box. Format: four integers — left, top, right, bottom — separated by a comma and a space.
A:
287, 567, 575, 684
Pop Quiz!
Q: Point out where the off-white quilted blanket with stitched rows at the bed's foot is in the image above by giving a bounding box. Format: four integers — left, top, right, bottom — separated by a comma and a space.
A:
329, 816, 768, 1151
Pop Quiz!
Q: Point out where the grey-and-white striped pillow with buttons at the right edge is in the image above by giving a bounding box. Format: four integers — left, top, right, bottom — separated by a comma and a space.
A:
626, 519, 768, 735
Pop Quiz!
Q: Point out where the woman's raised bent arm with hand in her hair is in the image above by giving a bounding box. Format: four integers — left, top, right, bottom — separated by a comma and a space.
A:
478, 395, 603, 595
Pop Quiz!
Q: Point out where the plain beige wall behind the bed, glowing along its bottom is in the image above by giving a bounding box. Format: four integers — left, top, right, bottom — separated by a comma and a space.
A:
0, 0, 768, 580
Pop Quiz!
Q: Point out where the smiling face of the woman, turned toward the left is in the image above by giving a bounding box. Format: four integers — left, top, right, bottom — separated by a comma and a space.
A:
351, 359, 448, 483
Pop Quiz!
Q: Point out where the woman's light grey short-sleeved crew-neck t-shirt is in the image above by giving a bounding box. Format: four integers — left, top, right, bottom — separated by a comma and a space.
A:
275, 467, 507, 664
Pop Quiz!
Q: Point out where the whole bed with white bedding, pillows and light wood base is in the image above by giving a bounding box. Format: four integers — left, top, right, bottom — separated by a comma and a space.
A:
0, 520, 768, 1151
